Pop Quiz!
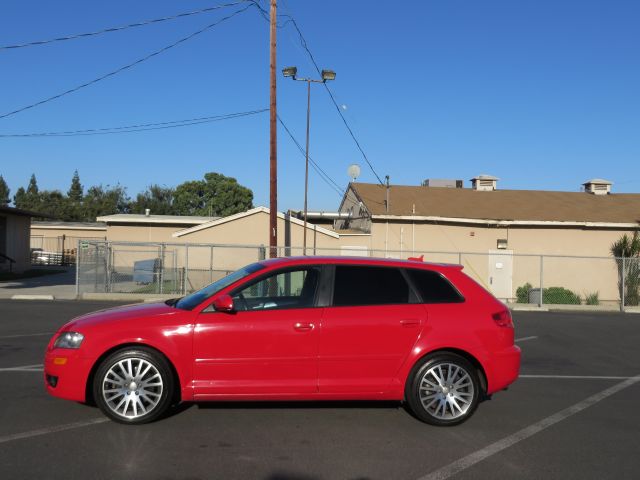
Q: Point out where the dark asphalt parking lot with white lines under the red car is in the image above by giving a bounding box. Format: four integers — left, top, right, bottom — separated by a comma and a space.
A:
0, 300, 640, 480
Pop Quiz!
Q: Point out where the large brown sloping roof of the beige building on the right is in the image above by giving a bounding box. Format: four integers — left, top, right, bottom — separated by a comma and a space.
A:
351, 183, 640, 227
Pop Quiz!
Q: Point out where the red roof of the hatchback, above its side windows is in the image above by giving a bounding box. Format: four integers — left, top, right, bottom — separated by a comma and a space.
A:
260, 256, 463, 270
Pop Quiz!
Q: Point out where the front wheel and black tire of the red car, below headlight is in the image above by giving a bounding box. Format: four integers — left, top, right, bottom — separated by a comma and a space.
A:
93, 347, 175, 425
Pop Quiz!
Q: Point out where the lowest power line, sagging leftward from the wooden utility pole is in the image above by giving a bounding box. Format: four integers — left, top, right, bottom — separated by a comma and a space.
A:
0, 108, 269, 138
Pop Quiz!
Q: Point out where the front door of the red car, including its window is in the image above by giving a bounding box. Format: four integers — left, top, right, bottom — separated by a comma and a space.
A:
194, 267, 322, 399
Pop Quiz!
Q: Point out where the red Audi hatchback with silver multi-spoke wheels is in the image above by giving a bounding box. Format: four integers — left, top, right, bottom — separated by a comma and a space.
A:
45, 257, 520, 425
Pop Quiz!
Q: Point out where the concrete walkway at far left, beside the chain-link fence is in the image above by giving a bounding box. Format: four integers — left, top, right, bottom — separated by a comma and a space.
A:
0, 266, 76, 300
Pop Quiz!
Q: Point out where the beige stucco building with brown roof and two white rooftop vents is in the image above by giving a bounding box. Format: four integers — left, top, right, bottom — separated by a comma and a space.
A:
335, 176, 640, 302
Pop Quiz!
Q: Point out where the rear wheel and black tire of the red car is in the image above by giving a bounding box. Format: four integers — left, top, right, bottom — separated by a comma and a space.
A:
405, 352, 482, 426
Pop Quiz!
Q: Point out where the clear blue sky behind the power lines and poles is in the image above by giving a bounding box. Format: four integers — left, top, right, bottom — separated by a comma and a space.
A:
0, 0, 640, 210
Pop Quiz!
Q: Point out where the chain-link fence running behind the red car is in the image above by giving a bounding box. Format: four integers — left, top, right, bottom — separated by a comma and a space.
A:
77, 240, 640, 308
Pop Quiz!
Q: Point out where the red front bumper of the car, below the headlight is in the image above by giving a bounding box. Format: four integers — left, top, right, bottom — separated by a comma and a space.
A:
44, 348, 92, 402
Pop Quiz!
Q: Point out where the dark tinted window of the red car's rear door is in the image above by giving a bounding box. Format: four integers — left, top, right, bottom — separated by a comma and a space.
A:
333, 265, 409, 307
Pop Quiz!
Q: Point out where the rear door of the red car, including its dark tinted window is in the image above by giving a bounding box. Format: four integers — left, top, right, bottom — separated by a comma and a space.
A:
318, 265, 427, 394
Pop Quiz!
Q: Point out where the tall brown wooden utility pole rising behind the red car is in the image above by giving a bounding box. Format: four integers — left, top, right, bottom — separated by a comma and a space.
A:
269, 0, 278, 258
